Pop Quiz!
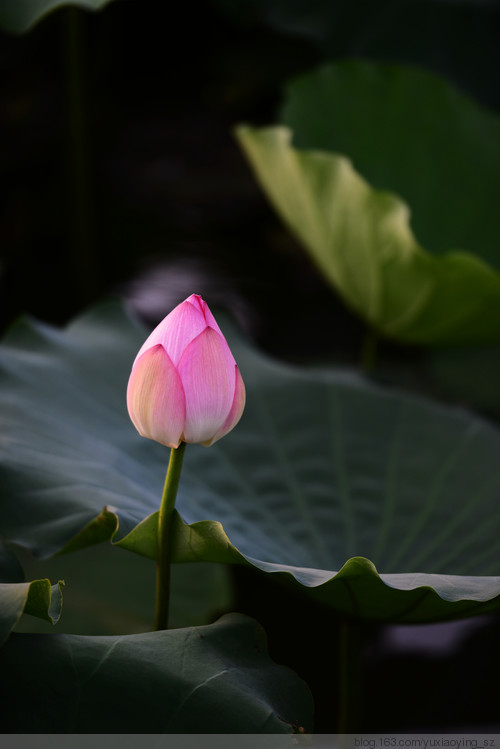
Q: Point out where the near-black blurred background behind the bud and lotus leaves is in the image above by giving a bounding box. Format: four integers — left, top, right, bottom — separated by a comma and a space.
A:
0, 0, 500, 732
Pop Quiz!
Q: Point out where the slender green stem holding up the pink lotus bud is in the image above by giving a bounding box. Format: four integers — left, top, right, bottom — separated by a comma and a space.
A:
155, 442, 186, 630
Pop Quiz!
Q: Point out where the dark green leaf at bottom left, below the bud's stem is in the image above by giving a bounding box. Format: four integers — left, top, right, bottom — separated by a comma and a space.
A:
0, 614, 312, 733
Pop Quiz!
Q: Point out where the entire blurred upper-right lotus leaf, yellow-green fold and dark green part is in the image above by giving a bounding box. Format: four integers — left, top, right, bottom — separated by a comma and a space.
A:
237, 63, 500, 344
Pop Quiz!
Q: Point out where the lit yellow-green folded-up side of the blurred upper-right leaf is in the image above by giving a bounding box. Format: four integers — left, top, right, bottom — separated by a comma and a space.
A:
237, 126, 500, 344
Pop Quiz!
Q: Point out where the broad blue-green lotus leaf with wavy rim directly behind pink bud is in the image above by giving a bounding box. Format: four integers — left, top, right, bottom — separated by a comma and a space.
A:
0, 305, 500, 621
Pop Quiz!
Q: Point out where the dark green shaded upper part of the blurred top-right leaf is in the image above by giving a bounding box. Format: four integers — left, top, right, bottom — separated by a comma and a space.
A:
280, 61, 500, 270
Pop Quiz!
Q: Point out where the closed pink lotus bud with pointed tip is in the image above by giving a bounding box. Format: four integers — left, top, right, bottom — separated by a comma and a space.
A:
127, 294, 245, 447
